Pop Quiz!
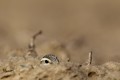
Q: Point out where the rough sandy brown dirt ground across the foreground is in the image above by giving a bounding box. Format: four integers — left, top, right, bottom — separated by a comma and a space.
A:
0, 51, 120, 80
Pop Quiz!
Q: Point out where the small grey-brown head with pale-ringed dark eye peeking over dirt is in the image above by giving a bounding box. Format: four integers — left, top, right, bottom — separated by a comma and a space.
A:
40, 54, 59, 65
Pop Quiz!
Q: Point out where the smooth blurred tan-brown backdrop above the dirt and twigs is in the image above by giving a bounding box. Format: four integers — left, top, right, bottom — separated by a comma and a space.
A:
0, 0, 120, 64
